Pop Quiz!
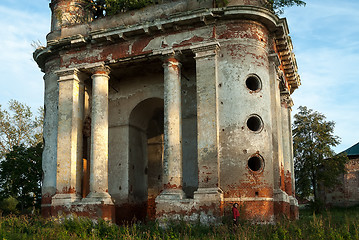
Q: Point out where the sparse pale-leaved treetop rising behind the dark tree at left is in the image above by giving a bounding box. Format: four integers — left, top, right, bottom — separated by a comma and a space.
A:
0, 100, 44, 159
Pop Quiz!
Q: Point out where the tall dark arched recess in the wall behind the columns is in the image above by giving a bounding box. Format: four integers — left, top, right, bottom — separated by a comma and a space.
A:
129, 98, 163, 219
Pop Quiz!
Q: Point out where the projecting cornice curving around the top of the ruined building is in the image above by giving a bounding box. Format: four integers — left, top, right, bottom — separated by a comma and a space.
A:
34, 5, 300, 90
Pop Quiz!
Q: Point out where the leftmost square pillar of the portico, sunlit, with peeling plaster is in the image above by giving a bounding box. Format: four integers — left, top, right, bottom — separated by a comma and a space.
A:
52, 69, 84, 205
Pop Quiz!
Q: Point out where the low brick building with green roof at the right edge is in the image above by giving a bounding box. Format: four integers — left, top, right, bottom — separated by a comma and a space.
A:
320, 143, 359, 207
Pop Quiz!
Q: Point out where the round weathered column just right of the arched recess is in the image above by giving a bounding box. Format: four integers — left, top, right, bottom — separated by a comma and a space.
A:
158, 54, 184, 199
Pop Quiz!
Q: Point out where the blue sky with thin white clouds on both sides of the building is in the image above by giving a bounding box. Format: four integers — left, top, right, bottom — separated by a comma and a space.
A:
0, 0, 359, 152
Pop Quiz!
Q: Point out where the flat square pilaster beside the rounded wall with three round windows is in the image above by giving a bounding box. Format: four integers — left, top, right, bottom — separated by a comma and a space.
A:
192, 43, 222, 198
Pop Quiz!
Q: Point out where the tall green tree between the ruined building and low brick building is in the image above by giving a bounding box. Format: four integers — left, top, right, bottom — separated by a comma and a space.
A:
293, 106, 347, 201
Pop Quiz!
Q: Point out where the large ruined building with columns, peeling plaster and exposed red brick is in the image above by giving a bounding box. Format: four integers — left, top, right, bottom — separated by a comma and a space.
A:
34, 0, 300, 223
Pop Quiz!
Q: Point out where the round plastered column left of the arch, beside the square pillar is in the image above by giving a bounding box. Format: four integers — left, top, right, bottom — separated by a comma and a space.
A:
86, 66, 113, 204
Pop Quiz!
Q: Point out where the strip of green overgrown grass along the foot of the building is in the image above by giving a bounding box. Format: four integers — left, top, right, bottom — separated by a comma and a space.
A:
0, 207, 359, 240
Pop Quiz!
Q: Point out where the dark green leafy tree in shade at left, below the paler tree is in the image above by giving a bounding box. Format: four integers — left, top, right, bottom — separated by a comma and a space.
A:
0, 143, 43, 212
